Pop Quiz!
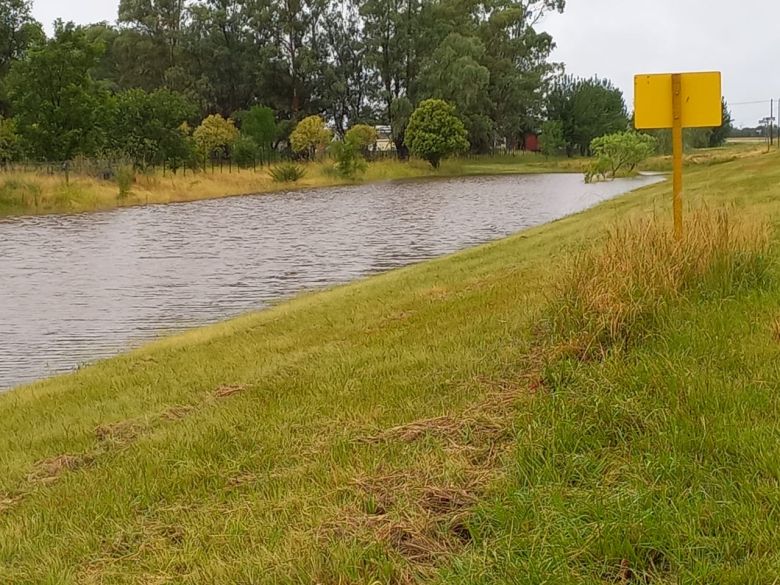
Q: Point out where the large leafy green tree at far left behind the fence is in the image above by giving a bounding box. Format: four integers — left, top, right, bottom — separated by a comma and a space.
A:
7, 21, 107, 161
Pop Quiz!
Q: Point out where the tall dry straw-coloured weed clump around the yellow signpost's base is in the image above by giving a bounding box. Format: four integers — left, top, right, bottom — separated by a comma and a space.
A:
539, 209, 771, 360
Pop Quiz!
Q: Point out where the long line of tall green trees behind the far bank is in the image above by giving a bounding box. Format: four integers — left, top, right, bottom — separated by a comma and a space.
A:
0, 0, 732, 169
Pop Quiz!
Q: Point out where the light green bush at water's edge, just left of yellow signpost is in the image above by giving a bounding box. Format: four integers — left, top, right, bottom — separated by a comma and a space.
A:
588, 130, 656, 179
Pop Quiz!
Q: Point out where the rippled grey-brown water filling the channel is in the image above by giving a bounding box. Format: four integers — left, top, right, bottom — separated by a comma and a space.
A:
0, 175, 659, 388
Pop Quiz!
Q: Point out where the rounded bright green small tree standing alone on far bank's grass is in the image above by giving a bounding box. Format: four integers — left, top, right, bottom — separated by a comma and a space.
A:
406, 99, 469, 168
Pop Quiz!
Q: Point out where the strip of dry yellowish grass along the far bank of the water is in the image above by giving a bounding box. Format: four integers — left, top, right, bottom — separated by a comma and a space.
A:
0, 153, 583, 217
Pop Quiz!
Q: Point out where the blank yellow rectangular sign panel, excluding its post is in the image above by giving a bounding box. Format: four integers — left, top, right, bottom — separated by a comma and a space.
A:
634, 72, 723, 129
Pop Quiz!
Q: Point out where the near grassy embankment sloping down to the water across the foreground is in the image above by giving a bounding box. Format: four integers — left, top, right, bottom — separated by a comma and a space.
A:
0, 145, 780, 585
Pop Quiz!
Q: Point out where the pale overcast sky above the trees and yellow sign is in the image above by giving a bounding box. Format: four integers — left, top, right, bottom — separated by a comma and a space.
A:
33, 0, 780, 126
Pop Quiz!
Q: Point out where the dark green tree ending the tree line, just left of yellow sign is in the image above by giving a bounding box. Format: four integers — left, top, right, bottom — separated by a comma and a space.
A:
547, 76, 629, 156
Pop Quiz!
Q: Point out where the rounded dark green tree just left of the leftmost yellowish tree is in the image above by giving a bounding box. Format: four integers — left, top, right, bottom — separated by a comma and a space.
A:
110, 89, 196, 168
